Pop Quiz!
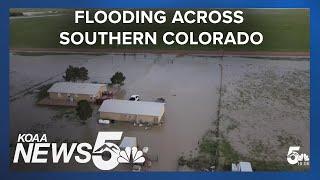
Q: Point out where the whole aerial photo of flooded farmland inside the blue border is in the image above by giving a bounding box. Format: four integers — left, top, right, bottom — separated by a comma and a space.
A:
9, 9, 310, 172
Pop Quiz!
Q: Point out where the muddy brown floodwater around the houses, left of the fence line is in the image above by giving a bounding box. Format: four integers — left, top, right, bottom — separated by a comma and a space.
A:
10, 54, 219, 171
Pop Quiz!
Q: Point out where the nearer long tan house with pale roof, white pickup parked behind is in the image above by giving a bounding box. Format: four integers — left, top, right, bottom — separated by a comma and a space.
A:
99, 99, 164, 124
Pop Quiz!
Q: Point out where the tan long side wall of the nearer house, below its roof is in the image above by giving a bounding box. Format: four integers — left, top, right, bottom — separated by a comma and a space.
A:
100, 112, 162, 124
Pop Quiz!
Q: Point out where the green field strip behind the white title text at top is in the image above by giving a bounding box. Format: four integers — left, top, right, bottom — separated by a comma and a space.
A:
10, 9, 309, 52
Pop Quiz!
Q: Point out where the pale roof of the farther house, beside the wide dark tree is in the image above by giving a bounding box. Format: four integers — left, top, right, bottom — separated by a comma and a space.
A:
48, 82, 105, 95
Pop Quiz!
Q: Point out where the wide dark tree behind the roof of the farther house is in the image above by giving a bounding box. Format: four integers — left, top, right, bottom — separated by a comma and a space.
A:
63, 65, 89, 82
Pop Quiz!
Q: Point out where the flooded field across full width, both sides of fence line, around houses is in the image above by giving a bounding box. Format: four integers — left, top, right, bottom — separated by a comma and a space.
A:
10, 54, 310, 171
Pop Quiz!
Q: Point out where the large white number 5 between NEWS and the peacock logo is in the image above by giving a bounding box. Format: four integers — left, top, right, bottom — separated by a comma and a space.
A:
92, 131, 122, 170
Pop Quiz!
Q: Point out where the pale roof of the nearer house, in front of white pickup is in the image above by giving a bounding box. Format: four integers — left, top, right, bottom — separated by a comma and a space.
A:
99, 99, 164, 116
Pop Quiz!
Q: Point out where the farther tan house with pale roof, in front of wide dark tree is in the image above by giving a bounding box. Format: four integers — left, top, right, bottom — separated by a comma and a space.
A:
48, 82, 107, 102
